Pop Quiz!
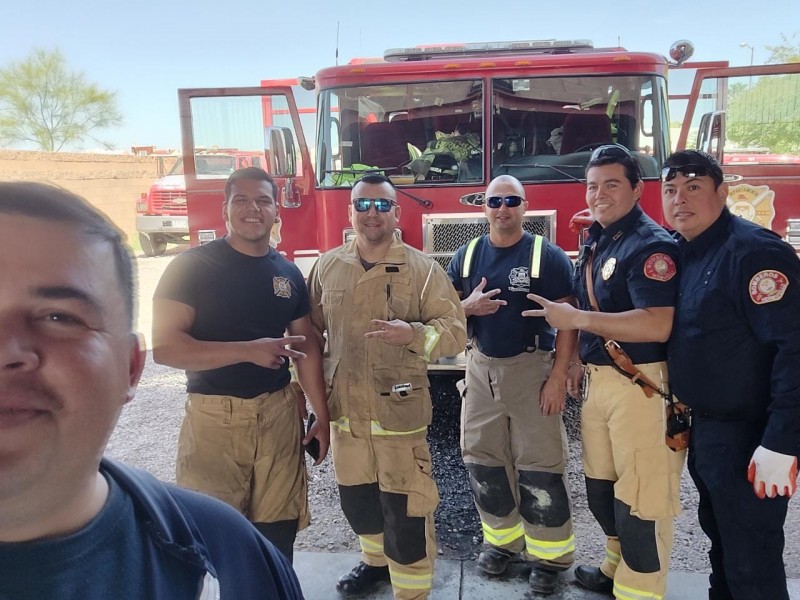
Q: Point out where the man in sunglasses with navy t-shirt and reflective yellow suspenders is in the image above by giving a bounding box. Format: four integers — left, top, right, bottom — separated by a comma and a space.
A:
448, 175, 577, 594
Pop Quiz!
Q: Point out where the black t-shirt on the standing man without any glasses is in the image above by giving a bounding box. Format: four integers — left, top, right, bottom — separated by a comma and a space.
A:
153, 238, 310, 398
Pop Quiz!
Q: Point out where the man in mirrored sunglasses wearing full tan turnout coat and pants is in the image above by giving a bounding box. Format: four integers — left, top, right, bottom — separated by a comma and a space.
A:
308, 174, 466, 600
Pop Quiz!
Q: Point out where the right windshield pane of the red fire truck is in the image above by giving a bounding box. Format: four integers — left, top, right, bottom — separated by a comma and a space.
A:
491, 76, 667, 181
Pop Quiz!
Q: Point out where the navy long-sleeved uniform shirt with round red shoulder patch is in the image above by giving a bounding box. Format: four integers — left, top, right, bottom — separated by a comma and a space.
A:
669, 209, 800, 455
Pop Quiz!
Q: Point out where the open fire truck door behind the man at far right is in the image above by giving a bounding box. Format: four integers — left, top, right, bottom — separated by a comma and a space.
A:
677, 63, 800, 244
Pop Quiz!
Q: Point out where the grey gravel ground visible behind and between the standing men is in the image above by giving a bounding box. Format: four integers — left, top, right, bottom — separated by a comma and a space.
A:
107, 251, 800, 578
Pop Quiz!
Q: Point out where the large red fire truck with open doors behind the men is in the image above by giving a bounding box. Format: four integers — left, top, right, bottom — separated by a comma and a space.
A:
179, 40, 800, 272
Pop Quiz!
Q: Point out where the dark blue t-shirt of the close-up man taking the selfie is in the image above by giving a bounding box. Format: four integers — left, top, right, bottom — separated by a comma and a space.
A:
0, 477, 192, 600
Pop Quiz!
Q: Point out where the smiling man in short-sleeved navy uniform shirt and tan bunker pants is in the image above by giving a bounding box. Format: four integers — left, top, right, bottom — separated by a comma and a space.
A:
528, 144, 686, 600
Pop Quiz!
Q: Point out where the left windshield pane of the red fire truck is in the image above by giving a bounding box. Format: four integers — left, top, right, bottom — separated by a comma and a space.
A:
317, 80, 483, 187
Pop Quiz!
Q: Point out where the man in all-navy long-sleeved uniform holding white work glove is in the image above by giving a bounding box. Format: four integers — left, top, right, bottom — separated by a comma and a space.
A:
662, 150, 800, 600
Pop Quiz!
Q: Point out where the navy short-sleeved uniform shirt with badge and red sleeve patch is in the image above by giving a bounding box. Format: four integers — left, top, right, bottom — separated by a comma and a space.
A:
573, 204, 678, 365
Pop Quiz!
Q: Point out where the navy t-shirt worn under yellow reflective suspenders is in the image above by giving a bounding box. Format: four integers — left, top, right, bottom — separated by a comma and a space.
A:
447, 232, 573, 358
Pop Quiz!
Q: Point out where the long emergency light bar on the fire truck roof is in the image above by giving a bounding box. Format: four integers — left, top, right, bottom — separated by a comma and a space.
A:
383, 40, 594, 62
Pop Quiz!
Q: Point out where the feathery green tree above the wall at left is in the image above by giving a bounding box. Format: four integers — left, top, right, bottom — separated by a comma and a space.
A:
0, 49, 122, 152
